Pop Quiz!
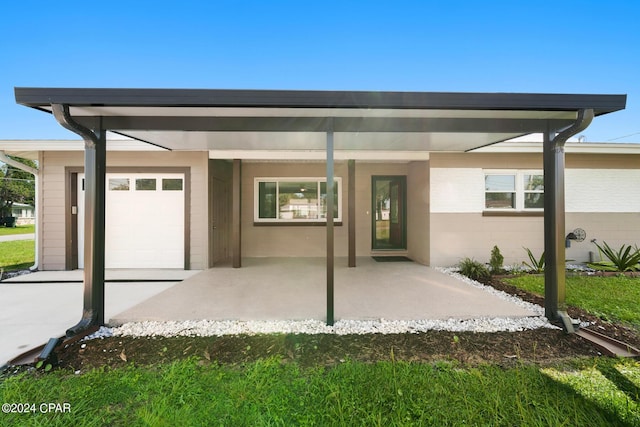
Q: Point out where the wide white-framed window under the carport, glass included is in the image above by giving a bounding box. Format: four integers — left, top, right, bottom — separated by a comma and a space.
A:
253, 177, 342, 224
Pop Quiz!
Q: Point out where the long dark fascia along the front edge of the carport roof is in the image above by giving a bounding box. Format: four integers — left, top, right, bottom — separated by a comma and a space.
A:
14, 87, 626, 115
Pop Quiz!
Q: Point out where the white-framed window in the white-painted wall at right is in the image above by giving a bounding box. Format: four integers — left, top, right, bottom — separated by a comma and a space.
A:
484, 169, 544, 212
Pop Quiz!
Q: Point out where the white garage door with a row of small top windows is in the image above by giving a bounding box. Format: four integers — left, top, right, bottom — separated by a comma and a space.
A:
78, 173, 185, 268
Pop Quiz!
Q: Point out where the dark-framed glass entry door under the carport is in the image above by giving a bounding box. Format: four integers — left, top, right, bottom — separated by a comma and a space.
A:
371, 176, 407, 250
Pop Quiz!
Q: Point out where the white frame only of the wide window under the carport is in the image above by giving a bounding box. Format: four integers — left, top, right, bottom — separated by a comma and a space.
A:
253, 177, 342, 225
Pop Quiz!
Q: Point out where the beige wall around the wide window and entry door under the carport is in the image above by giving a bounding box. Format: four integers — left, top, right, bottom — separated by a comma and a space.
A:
242, 161, 428, 260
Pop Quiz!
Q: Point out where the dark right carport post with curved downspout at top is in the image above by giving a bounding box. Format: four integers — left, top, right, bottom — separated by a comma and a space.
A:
543, 109, 594, 333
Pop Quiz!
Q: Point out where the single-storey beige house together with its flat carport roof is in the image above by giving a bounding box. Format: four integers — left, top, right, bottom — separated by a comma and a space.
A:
5, 88, 628, 323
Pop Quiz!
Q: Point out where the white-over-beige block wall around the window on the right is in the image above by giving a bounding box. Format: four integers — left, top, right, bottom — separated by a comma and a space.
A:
430, 153, 640, 266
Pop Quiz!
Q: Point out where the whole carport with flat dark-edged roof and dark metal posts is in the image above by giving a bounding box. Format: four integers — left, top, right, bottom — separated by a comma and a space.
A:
15, 88, 626, 334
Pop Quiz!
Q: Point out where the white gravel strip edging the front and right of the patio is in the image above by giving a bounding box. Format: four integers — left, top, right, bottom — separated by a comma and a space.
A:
85, 268, 559, 339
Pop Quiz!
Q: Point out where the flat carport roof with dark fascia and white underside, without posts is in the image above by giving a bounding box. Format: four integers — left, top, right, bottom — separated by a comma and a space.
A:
15, 88, 626, 151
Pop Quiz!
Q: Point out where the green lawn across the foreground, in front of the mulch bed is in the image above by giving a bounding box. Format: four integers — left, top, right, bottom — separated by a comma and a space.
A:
0, 358, 640, 426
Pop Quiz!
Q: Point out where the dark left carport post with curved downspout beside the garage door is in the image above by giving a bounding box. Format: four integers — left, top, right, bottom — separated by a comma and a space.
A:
52, 104, 107, 337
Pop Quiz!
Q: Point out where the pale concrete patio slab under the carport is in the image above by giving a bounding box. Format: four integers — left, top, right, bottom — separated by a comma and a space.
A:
109, 257, 535, 325
